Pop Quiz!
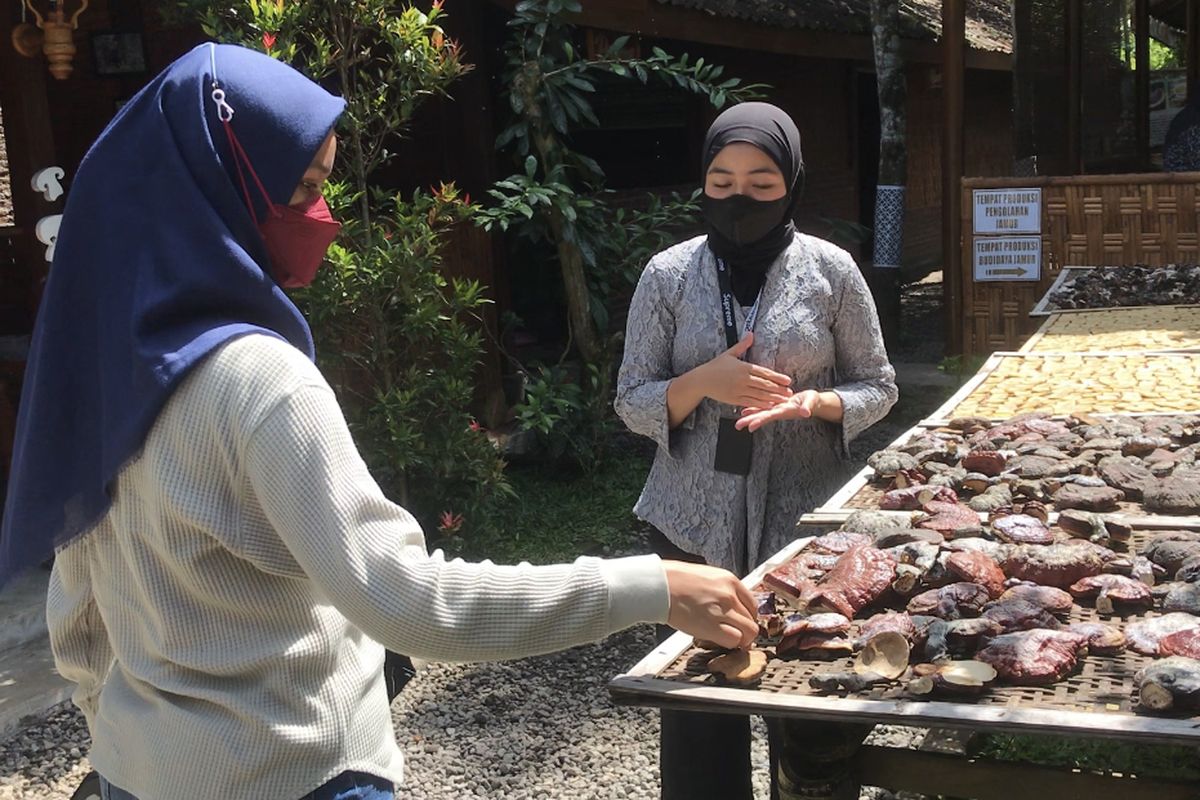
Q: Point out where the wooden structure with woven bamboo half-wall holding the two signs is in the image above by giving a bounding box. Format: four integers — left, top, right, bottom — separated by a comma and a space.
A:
941, 0, 1200, 355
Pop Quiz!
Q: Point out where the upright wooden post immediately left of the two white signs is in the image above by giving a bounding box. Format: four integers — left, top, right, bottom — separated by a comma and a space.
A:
942, 0, 967, 355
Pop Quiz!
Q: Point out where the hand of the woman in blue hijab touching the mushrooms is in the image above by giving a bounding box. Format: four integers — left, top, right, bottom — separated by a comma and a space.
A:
662, 561, 758, 649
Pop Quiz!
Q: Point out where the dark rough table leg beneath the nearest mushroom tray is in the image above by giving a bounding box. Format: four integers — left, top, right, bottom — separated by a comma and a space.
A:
768, 720, 874, 800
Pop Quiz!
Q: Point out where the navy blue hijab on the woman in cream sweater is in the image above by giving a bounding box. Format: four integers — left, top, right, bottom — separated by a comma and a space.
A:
0, 44, 344, 587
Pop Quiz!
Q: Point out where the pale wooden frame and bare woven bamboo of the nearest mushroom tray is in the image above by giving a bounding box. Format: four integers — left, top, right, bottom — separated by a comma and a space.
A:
608, 531, 1200, 745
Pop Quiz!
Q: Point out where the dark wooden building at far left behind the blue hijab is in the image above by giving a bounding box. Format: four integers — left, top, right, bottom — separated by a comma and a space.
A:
0, 0, 208, 500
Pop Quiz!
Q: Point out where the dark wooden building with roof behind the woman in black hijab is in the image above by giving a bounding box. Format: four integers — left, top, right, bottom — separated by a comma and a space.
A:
466, 0, 1013, 273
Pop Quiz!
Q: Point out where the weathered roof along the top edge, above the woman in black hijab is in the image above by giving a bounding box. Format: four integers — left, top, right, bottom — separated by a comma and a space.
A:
659, 0, 1013, 53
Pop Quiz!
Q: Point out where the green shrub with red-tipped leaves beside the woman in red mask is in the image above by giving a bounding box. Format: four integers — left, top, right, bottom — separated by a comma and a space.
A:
168, 0, 511, 534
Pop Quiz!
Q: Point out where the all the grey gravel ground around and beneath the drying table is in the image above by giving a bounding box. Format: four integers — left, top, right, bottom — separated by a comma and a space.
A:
0, 284, 955, 800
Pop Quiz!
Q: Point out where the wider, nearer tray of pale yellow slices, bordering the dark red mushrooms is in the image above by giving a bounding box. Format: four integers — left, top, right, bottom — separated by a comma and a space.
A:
929, 353, 1200, 423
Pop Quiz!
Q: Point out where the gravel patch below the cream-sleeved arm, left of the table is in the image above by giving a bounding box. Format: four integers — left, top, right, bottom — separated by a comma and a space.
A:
392, 626, 658, 800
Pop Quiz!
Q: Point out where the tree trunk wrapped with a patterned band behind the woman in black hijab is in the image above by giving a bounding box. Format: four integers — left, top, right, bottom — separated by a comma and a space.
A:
871, 0, 908, 350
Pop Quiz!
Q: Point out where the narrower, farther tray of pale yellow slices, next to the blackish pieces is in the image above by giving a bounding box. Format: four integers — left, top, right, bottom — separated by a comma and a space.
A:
1020, 306, 1200, 353
